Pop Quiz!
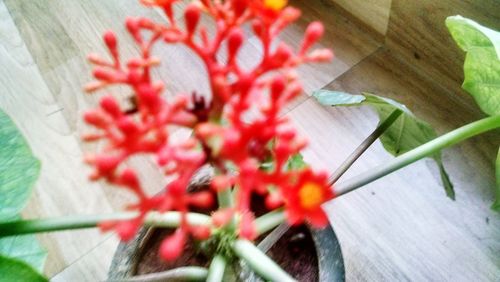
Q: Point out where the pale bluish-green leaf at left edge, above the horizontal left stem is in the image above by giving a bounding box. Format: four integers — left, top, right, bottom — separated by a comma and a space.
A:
0, 111, 40, 222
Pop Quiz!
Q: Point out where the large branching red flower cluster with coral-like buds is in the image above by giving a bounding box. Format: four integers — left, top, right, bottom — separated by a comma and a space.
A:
84, 0, 333, 259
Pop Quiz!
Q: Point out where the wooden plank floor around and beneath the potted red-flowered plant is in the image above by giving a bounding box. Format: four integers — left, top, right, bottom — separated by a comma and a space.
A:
0, 0, 500, 281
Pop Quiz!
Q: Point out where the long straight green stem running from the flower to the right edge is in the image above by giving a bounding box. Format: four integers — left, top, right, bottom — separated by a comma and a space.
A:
334, 116, 500, 196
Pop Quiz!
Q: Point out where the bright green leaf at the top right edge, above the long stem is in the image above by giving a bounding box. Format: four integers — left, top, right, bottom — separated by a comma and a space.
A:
446, 16, 500, 115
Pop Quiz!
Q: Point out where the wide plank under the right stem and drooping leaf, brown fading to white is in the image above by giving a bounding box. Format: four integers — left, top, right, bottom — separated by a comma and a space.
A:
290, 49, 500, 281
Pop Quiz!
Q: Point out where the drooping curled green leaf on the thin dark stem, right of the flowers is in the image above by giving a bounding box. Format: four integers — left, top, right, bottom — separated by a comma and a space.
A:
313, 90, 455, 199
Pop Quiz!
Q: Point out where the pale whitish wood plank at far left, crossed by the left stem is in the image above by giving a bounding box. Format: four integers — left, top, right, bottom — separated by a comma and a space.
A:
0, 1, 116, 275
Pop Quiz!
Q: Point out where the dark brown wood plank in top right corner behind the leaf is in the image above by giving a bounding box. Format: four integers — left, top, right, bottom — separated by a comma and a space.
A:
386, 0, 500, 102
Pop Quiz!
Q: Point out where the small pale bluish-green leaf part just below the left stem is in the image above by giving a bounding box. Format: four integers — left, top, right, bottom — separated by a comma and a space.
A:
0, 235, 47, 272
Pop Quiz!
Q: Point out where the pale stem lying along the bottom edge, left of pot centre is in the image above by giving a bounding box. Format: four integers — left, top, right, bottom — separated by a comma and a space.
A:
107, 266, 208, 282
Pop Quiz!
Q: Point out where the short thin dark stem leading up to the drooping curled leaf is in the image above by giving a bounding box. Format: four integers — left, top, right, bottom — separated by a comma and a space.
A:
328, 109, 403, 185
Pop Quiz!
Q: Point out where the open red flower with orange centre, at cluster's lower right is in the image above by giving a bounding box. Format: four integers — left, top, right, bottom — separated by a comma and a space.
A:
283, 168, 334, 227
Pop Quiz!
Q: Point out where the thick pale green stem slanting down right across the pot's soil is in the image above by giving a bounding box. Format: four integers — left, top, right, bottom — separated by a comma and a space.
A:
232, 239, 296, 282
